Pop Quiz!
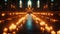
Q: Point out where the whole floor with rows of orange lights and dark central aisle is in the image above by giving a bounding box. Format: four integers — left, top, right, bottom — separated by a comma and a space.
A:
0, 12, 60, 34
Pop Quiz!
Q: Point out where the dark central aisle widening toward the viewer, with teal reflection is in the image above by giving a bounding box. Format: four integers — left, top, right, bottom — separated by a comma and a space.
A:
17, 14, 41, 34
